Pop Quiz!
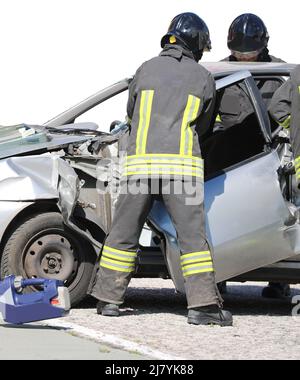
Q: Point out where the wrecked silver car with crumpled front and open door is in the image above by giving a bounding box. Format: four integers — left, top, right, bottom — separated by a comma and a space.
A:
0, 62, 300, 305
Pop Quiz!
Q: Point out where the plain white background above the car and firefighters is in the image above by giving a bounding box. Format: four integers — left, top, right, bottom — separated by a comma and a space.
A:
0, 0, 300, 129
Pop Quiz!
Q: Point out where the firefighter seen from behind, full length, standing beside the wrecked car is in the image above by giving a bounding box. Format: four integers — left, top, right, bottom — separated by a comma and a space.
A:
91, 13, 232, 326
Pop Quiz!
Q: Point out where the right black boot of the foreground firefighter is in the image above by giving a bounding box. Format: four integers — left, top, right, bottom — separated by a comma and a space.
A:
188, 305, 233, 327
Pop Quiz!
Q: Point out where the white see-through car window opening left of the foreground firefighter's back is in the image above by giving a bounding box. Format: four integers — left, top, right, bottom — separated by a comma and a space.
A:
75, 91, 128, 132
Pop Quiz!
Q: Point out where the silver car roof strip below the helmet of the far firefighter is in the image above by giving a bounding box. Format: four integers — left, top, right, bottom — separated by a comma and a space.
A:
201, 61, 297, 77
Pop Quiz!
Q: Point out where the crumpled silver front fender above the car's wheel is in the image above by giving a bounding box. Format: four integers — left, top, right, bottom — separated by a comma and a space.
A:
0, 153, 105, 248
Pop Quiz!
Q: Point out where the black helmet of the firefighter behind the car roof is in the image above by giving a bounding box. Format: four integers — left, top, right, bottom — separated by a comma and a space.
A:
227, 13, 269, 53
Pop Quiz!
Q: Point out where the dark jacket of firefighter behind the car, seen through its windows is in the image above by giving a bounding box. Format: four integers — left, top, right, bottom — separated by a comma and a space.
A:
217, 49, 284, 129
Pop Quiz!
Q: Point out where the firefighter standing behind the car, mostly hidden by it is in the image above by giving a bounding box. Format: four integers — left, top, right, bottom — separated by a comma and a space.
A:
215, 13, 290, 298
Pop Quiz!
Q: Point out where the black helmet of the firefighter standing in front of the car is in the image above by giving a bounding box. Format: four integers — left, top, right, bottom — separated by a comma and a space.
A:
161, 12, 211, 55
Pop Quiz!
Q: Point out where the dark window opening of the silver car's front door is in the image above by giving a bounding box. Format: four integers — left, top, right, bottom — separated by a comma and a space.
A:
201, 77, 266, 176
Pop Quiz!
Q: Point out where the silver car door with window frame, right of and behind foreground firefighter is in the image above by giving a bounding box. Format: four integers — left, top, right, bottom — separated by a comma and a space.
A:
149, 72, 300, 291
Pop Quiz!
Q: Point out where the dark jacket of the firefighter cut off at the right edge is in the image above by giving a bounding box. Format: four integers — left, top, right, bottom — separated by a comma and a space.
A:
269, 65, 300, 183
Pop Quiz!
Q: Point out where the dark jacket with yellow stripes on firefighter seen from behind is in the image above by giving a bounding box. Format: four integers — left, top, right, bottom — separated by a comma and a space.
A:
124, 45, 216, 178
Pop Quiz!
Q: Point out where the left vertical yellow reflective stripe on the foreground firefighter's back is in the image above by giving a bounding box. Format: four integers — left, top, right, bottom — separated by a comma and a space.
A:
136, 90, 154, 154
